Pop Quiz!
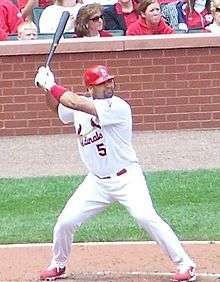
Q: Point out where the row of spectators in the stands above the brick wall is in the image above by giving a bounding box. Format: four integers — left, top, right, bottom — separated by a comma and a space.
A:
0, 0, 220, 40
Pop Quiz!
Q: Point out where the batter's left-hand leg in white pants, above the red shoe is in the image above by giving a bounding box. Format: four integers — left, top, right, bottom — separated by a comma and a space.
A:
51, 175, 110, 268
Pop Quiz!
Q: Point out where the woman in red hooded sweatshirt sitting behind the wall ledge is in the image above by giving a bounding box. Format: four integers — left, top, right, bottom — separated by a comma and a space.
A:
126, 0, 174, 35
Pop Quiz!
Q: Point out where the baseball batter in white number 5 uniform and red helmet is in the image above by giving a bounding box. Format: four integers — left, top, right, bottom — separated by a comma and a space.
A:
35, 65, 196, 281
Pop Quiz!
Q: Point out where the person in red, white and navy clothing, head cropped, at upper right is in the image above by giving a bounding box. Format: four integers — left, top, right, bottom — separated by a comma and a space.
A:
177, 0, 213, 31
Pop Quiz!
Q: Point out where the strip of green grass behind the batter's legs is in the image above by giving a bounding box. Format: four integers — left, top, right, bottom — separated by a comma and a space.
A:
0, 170, 220, 244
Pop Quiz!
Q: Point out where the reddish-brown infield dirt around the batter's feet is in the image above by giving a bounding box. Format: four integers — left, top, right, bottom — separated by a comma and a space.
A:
0, 242, 220, 282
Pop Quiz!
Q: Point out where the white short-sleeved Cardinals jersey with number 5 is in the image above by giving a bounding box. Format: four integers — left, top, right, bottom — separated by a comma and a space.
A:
58, 96, 138, 177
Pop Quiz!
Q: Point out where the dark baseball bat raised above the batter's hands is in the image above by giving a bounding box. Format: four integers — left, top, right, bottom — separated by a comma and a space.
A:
46, 11, 70, 66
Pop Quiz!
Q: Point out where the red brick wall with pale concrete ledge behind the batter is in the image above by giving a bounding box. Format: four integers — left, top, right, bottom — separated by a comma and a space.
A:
0, 34, 220, 136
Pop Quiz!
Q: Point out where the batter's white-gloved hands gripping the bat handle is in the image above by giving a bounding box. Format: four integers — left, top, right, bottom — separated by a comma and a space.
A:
34, 66, 55, 91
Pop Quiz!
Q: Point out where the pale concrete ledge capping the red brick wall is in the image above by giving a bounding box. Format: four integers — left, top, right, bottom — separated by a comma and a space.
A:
0, 33, 220, 56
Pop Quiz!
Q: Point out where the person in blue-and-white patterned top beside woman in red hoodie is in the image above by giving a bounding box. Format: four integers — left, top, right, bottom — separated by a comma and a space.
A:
159, 0, 179, 29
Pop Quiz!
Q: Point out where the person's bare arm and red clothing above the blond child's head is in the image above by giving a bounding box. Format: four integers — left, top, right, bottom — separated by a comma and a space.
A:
20, 0, 54, 20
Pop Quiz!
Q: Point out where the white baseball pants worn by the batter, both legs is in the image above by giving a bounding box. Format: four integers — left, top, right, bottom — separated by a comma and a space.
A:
50, 164, 194, 267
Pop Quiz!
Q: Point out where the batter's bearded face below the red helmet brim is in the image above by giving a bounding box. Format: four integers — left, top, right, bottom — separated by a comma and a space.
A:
91, 79, 115, 99
